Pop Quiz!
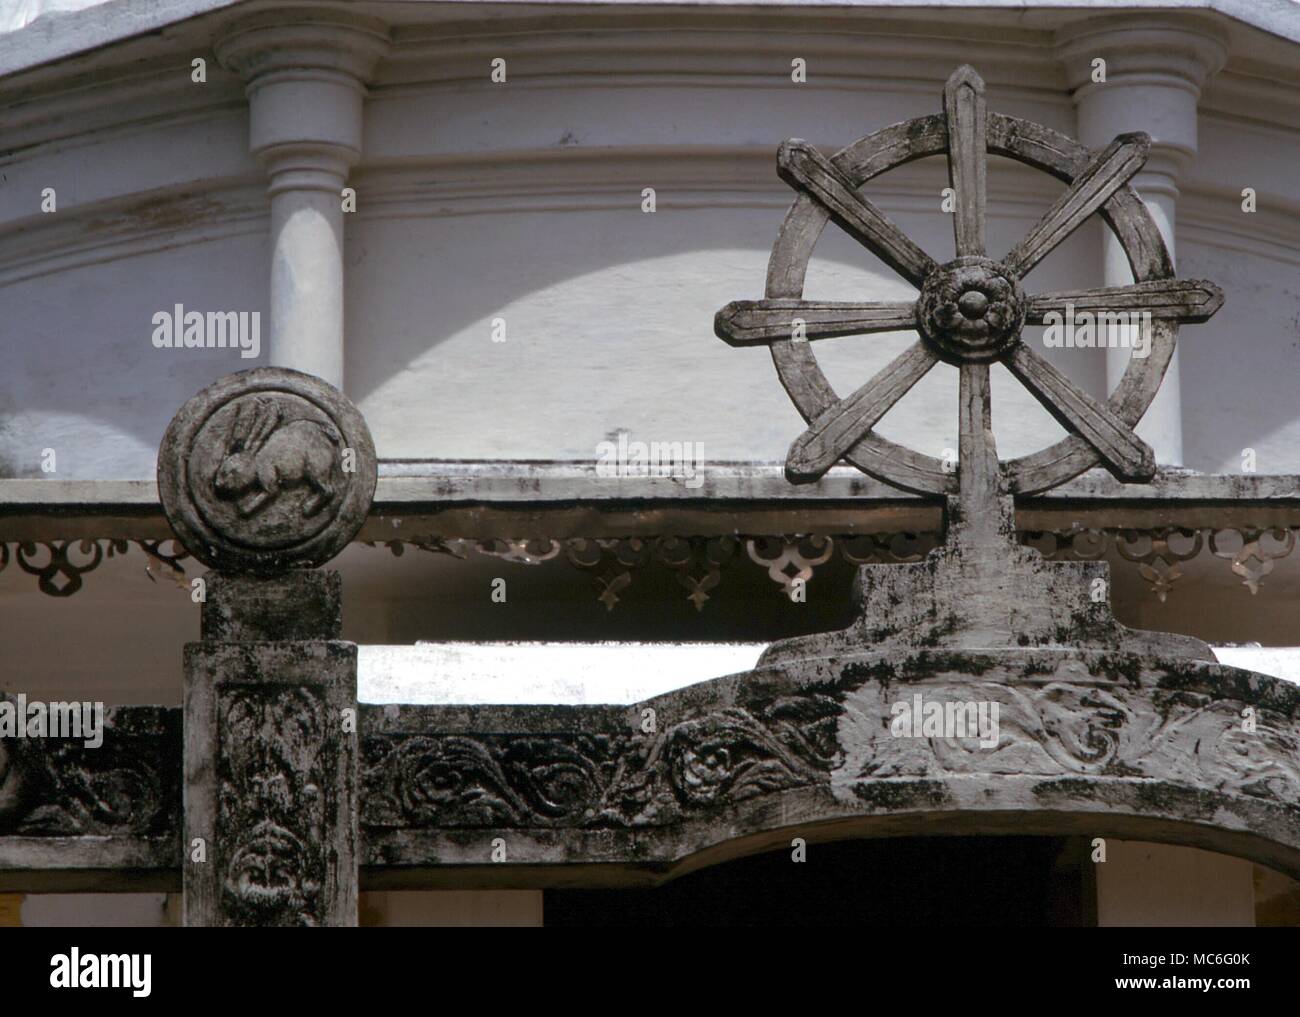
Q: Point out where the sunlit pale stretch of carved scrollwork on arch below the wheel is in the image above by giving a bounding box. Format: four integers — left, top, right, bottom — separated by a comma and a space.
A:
844, 658, 1300, 804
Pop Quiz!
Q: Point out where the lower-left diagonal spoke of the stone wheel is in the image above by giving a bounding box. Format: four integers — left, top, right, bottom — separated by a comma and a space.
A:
785, 342, 939, 484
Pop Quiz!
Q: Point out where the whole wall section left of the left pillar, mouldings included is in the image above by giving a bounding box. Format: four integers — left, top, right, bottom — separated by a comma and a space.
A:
0, 83, 268, 480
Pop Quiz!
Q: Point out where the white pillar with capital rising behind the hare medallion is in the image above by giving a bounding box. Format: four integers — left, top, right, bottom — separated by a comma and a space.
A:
215, 8, 389, 388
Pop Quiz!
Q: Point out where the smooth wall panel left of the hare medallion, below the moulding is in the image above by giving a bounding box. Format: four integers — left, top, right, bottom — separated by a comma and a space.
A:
0, 235, 267, 480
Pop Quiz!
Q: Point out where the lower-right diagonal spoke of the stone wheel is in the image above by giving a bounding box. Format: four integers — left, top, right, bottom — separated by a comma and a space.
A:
1005, 342, 1156, 482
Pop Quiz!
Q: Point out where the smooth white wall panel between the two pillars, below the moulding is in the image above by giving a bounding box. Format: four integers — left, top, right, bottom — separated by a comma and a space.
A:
347, 146, 1105, 460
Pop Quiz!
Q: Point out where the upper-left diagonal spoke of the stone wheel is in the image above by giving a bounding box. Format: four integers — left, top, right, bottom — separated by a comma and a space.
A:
776, 138, 935, 287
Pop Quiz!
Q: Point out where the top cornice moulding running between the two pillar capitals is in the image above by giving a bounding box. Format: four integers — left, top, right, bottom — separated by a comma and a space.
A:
376, 10, 1065, 91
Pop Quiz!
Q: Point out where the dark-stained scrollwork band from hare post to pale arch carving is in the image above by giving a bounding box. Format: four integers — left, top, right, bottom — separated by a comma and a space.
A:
361, 691, 839, 828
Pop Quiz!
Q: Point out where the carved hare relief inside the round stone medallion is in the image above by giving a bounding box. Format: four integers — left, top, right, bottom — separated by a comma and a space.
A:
212, 399, 342, 519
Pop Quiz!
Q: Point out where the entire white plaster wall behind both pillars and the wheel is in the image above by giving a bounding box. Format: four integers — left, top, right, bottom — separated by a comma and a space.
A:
0, 10, 1300, 477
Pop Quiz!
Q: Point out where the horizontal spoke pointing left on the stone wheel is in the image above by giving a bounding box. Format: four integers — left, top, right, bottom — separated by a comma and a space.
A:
714, 299, 917, 346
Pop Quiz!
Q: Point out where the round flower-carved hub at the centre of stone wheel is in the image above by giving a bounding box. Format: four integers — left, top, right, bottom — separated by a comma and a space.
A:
917, 256, 1026, 364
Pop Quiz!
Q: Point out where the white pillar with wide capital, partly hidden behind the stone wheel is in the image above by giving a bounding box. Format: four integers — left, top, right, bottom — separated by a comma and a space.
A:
1057, 14, 1227, 466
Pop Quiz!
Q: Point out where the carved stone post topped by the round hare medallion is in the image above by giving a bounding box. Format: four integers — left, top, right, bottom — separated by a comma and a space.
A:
159, 368, 376, 926
